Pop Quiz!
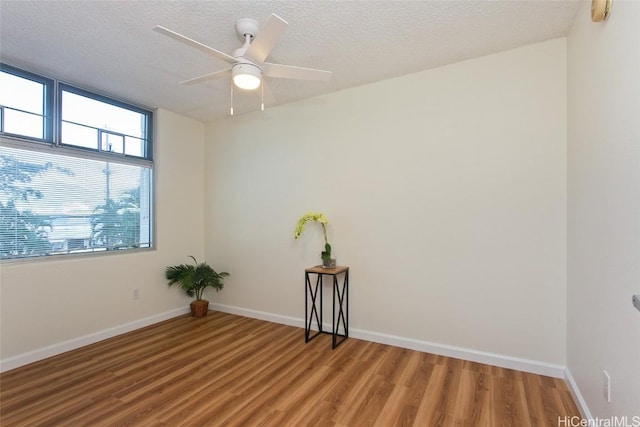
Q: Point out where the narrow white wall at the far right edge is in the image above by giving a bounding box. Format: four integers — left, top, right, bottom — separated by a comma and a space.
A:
567, 0, 640, 418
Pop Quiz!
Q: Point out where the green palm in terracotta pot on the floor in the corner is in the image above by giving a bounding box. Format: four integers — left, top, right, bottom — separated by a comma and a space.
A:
164, 255, 229, 317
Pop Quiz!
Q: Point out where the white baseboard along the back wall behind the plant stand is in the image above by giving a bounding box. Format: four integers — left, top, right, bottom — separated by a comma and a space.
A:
212, 303, 567, 379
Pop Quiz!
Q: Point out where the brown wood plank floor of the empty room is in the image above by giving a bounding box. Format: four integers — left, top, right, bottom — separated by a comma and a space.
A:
0, 312, 579, 427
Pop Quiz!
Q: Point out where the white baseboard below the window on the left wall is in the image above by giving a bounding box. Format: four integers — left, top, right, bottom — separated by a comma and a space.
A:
0, 306, 190, 372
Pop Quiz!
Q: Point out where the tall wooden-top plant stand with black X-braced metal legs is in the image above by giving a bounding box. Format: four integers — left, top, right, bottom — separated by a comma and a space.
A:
304, 265, 349, 348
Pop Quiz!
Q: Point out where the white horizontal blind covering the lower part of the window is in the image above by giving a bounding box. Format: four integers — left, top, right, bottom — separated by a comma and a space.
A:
0, 146, 153, 259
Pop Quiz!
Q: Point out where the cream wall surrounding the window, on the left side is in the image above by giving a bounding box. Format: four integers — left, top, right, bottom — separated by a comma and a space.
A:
0, 110, 204, 366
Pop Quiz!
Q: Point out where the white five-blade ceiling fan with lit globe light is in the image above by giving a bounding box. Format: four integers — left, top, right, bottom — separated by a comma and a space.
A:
153, 14, 331, 114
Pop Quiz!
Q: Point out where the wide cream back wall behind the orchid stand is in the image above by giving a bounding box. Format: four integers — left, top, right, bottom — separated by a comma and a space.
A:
205, 39, 566, 365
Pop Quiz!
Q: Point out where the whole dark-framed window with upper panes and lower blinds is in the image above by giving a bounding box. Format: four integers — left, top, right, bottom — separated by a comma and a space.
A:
0, 64, 153, 259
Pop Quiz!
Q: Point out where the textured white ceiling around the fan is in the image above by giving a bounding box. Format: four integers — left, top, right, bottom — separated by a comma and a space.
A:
0, 0, 580, 122
